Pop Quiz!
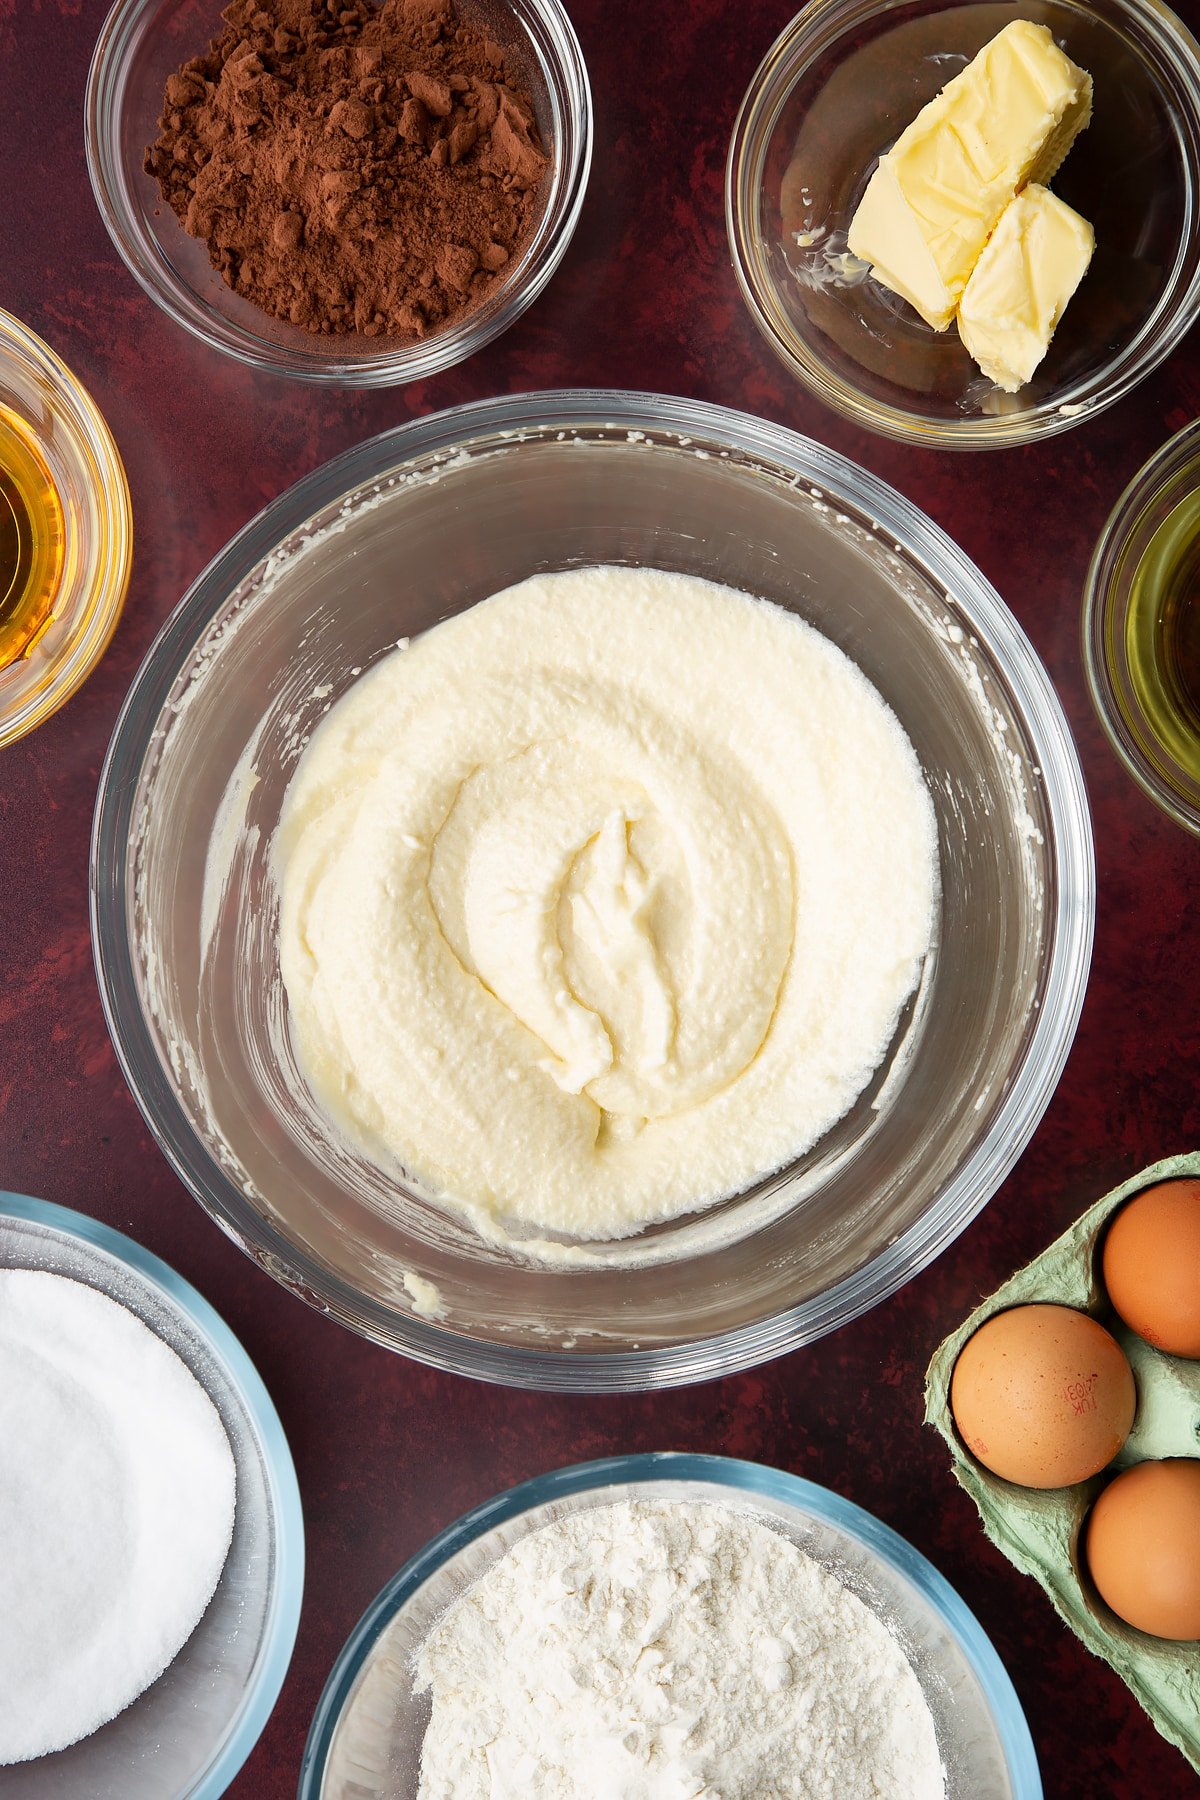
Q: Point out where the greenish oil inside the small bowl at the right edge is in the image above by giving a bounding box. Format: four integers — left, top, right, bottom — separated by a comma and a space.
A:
1124, 491, 1200, 781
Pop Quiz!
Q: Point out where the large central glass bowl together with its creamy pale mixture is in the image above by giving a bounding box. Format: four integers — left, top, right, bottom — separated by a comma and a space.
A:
92, 392, 1094, 1390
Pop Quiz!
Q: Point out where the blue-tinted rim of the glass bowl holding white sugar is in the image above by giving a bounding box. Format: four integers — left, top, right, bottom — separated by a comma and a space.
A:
0, 1190, 304, 1800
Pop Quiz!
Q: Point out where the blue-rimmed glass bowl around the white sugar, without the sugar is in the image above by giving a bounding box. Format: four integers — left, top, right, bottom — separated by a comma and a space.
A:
0, 1193, 304, 1800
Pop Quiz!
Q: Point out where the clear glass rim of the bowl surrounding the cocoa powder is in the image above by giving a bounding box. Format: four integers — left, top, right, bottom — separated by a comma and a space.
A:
83, 0, 596, 389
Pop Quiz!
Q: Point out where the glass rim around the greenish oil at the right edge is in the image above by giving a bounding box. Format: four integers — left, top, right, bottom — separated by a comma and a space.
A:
1079, 419, 1200, 837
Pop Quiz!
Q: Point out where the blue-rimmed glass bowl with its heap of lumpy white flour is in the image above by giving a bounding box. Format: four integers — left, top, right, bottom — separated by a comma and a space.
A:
300, 1454, 1042, 1800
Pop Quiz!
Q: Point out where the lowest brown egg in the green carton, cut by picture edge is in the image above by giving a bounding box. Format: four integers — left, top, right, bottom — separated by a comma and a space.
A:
1085, 1456, 1200, 1640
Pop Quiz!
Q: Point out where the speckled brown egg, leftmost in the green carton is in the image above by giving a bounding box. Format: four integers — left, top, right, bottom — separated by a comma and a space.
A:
950, 1305, 1137, 1487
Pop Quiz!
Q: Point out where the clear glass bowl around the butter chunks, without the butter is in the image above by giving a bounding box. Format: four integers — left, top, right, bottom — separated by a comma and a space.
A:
725, 0, 1200, 450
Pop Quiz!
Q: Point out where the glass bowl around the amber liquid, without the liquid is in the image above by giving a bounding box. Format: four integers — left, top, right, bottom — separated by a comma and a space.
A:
0, 311, 133, 747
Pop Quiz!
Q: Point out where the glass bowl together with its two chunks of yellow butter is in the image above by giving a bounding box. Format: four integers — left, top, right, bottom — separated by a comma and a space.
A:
727, 0, 1200, 450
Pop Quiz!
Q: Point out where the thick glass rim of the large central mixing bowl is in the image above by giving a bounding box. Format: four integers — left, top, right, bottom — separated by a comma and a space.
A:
90, 389, 1096, 1393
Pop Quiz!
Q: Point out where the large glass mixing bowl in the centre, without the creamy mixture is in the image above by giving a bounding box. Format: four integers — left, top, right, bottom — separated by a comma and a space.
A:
92, 392, 1094, 1390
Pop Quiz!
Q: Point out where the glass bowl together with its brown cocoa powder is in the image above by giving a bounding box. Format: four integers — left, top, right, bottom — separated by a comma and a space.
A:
85, 0, 592, 387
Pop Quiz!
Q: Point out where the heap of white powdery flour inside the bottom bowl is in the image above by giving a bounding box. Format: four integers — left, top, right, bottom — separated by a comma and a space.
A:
416, 1501, 945, 1800
